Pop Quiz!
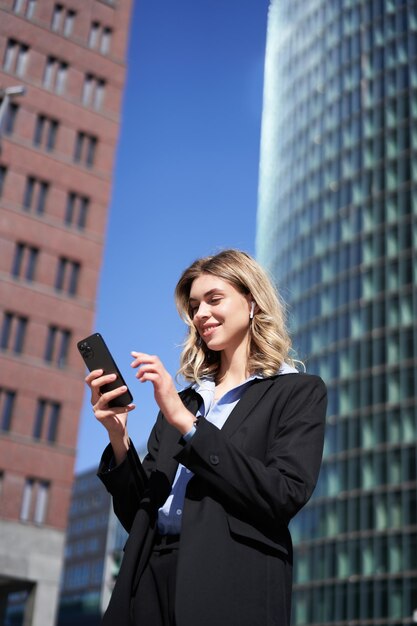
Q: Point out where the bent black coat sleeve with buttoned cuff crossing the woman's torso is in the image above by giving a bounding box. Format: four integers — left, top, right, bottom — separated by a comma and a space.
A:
177, 374, 327, 528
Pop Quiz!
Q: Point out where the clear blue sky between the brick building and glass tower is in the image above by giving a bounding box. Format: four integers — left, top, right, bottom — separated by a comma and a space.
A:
76, 0, 268, 471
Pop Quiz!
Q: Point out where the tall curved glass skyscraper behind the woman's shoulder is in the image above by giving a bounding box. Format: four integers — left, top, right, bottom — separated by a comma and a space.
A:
257, 0, 417, 626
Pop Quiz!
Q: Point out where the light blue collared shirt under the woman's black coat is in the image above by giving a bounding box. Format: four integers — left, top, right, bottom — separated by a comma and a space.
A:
158, 363, 297, 535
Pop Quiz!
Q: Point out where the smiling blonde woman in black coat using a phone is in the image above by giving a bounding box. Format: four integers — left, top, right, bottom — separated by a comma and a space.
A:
86, 250, 326, 626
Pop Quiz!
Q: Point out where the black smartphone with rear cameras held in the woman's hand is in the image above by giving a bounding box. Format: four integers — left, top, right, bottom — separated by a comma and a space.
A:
77, 333, 133, 406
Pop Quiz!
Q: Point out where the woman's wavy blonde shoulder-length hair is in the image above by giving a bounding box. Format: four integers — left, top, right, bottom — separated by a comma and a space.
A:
175, 250, 294, 381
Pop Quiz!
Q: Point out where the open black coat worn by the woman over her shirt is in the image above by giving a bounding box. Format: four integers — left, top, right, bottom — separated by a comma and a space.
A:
99, 374, 326, 626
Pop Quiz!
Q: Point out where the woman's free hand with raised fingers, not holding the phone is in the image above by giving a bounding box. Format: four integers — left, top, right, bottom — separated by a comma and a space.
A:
131, 352, 195, 435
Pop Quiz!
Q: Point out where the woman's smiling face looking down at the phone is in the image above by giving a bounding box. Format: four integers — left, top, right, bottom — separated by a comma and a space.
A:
189, 274, 252, 351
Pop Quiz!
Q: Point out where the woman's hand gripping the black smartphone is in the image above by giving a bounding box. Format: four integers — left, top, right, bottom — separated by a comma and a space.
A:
85, 370, 135, 464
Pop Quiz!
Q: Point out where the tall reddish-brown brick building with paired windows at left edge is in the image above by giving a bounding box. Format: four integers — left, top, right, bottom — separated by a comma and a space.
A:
0, 0, 132, 626
